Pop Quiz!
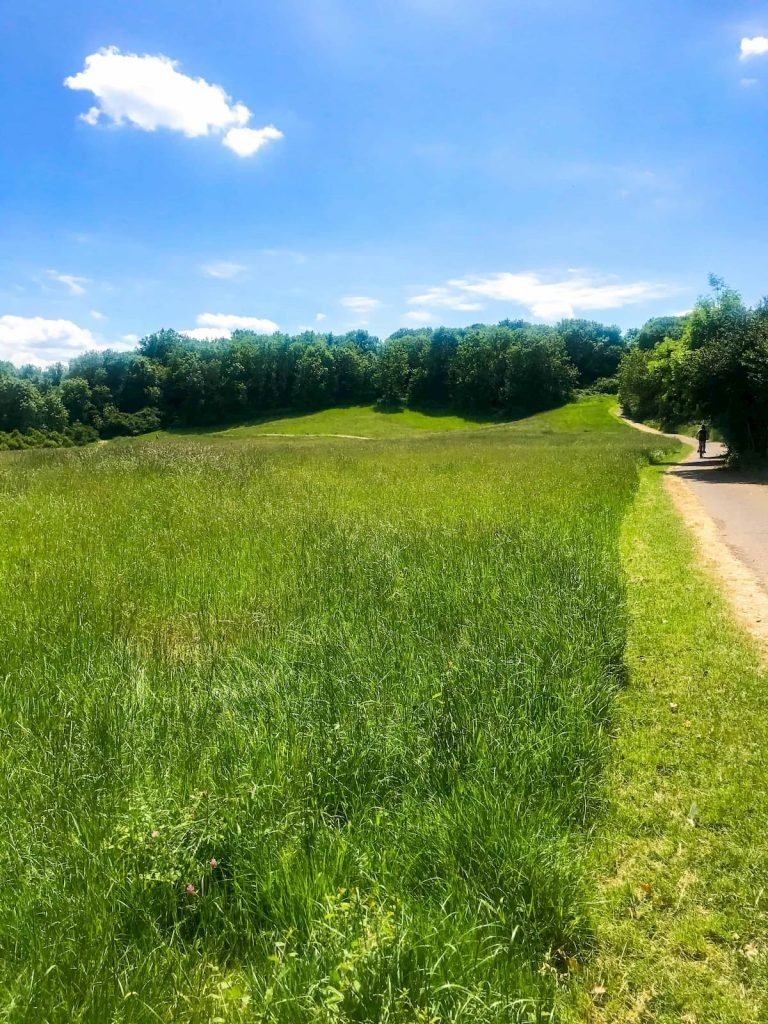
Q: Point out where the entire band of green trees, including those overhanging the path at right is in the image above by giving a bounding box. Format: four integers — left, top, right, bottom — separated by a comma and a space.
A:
0, 278, 768, 458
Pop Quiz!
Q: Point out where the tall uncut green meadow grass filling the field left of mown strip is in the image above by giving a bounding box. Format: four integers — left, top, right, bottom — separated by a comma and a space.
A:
0, 403, 648, 1024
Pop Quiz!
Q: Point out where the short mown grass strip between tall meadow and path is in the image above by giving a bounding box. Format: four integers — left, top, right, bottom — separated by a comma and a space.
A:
563, 467, 768, 1024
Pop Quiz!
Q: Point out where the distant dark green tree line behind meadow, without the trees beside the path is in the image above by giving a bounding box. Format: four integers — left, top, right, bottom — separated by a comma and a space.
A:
0, 321, 624, 449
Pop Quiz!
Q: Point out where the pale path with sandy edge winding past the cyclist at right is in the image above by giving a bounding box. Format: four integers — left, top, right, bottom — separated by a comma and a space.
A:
626, 420, 768, 657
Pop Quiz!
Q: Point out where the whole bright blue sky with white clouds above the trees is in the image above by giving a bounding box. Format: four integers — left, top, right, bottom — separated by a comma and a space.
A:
0, 0, 768, 362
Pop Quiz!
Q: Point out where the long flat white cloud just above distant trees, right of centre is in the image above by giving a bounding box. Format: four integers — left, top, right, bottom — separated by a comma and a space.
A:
434, 270, 677, 321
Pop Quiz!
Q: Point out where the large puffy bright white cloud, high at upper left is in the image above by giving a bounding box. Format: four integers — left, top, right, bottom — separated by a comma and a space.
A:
63, 46, 283, 157
